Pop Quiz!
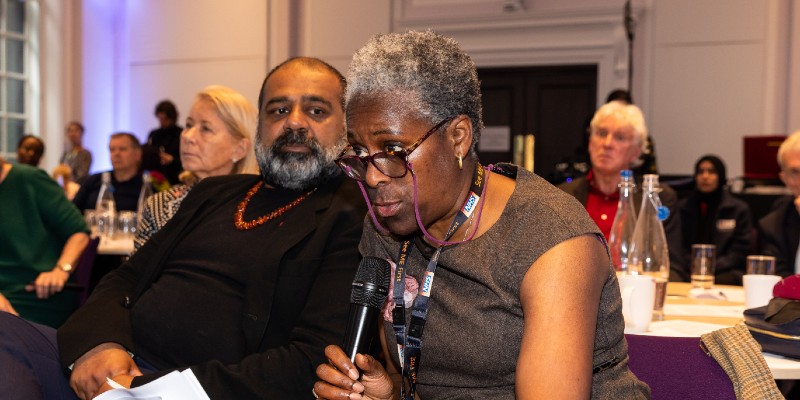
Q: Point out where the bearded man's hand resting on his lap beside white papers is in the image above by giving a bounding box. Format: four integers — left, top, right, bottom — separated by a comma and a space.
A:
69, 343, 142, 400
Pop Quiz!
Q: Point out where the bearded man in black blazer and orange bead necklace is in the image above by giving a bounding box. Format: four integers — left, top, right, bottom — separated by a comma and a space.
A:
0, 58, 365, 399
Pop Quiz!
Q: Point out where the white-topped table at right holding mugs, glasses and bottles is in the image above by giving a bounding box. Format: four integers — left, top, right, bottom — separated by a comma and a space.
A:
642, 282, 800, 379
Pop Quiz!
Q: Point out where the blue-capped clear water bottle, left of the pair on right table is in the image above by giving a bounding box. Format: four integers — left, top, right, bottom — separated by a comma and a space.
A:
608, 169, 636, 273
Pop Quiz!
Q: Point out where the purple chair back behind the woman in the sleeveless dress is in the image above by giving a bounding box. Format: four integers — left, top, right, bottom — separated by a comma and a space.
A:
625, 335, 736, 400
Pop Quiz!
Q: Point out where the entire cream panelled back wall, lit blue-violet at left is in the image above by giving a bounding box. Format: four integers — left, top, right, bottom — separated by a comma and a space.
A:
42, 0, 800, 177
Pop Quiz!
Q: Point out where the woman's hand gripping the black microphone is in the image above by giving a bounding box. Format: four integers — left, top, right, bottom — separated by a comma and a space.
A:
314, 345, 394, 400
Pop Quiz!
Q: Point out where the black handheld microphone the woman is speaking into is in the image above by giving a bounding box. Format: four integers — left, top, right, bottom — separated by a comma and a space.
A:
342, 257, 392, 363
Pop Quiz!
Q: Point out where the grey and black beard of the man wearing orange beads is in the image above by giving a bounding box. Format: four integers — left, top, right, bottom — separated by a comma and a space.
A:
255, 129, 344, 191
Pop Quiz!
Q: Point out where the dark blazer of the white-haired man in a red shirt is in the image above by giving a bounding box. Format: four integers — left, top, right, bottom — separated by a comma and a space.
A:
558, 177, 689, 282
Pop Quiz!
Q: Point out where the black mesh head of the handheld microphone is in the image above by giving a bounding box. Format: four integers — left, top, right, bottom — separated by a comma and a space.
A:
350, 257, 392, 310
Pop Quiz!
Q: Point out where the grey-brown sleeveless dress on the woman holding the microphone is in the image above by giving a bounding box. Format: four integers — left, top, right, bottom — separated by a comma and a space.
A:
360, 165, 650, 400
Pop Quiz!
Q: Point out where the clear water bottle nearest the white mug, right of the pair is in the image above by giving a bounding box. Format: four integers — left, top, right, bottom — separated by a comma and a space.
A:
628, 175, 669, 321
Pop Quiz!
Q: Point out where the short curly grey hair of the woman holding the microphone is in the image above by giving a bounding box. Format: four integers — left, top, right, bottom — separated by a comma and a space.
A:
345, 31, 483, 151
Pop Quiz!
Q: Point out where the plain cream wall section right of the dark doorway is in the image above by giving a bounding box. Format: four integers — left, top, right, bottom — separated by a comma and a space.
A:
648, 0, 789, 176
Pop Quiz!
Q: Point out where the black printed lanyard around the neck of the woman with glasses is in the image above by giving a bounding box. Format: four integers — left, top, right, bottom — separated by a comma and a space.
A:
392, 164, 486, 400
